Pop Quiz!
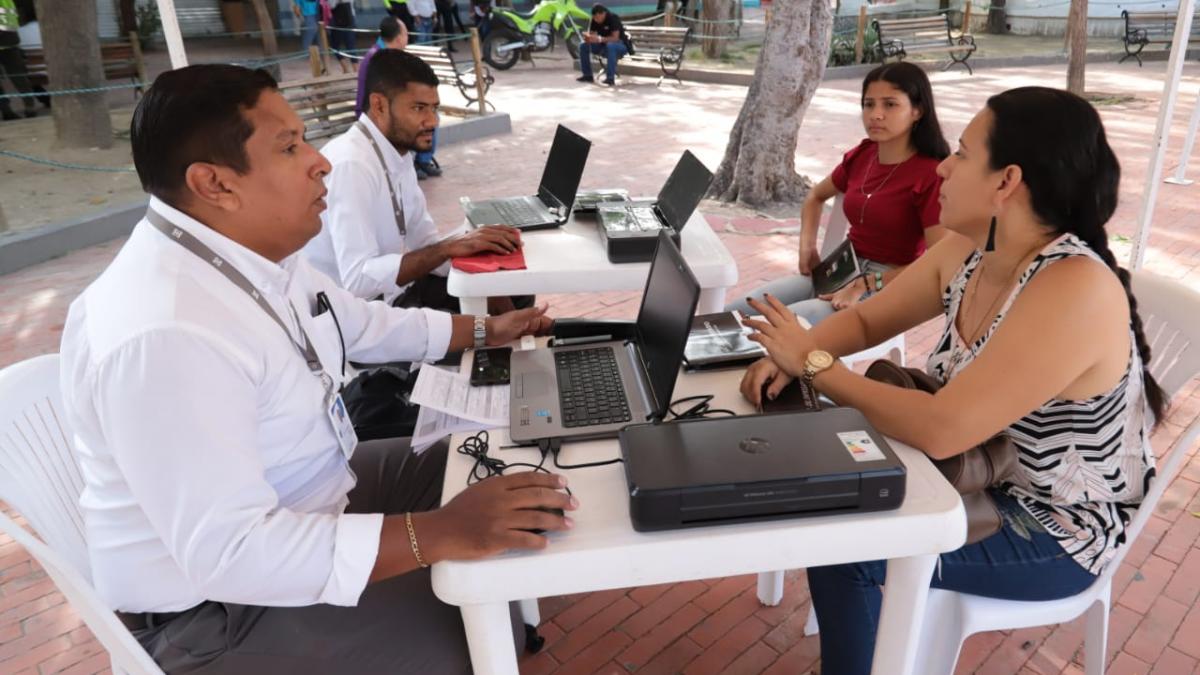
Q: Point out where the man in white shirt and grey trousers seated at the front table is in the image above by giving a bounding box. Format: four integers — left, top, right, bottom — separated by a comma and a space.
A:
61, 65, 576, 673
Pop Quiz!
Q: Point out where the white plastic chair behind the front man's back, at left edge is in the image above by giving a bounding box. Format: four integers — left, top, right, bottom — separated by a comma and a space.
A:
0, 354, 162, 675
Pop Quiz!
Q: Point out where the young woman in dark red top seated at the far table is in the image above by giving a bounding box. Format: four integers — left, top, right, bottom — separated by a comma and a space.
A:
726, 61, 950, 324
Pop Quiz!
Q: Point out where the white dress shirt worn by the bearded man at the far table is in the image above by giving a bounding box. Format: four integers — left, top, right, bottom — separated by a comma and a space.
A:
304, 114, 450, 304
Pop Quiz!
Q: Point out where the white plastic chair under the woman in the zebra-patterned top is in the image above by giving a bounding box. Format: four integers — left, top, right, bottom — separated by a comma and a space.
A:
917, 273, 1200, 675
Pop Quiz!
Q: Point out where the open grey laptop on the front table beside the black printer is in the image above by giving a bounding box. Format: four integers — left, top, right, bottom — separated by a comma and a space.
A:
509, 232, 700, 444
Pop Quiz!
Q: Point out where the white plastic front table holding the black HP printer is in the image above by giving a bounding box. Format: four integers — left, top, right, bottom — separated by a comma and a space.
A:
433, 358, 966, 675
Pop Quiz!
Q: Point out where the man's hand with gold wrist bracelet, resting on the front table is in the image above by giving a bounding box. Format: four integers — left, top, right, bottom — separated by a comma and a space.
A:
413, 471, 580, 557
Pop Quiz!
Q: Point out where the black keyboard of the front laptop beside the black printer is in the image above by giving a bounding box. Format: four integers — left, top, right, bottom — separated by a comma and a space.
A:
554, 347, 630, 428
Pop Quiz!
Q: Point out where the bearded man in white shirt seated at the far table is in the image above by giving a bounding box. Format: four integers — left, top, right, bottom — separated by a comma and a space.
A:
304, 49, 520, 313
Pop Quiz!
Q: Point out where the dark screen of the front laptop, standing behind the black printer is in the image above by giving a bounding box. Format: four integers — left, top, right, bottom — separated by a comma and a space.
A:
637, 231, 700, 419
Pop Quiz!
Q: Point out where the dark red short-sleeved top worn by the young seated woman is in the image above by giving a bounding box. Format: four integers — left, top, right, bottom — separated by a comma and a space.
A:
832, 139, 942, 265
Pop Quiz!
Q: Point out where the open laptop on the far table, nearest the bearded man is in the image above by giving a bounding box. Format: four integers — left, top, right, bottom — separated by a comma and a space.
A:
463, 125, 592, 229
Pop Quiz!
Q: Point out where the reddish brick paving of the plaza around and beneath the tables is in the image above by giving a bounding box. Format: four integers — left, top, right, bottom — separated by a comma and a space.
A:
0, 64, 1200, 675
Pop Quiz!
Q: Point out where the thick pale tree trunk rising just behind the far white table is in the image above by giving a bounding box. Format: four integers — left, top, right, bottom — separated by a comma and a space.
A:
709, 0, 833, 207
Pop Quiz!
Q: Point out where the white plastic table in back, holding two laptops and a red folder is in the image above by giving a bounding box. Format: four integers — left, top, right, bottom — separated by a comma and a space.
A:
446, 211, 738, 315
